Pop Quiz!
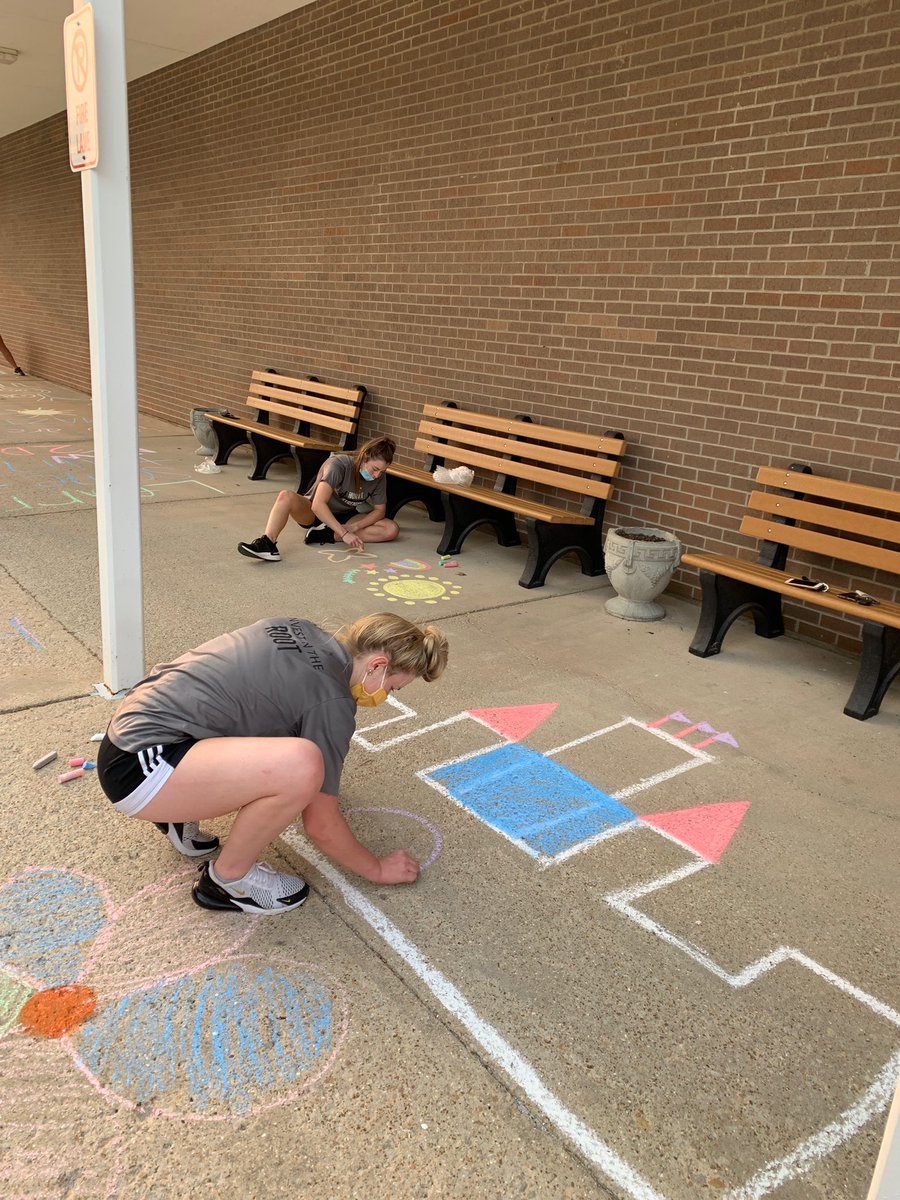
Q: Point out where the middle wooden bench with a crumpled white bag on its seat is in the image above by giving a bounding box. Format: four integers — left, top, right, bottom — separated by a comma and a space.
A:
388, 403, 625, 588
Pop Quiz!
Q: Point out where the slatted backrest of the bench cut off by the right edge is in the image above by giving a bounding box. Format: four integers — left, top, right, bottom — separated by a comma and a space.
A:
740, 463, 900, 575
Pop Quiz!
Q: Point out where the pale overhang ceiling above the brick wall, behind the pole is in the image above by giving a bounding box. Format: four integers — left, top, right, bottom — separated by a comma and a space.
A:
0, 0, 313, 138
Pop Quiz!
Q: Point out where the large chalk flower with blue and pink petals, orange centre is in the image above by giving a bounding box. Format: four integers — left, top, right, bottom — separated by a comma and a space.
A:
0, 868, 348, 1124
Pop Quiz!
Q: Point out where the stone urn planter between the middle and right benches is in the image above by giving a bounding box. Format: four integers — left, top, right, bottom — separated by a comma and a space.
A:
605, 528, 682, 620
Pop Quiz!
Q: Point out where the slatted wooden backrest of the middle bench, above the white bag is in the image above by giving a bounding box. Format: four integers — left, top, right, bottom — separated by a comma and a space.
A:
415, 404, 625, 499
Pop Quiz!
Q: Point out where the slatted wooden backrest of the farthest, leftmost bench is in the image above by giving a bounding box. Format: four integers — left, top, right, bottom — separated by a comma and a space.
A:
247, 371, 366, 450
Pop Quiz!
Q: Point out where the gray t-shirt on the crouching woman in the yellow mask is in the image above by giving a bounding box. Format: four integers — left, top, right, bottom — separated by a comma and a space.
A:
108, 617, 356, 796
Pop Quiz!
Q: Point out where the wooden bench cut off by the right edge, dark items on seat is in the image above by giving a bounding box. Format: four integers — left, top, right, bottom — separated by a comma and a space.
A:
682, 463, 900, 721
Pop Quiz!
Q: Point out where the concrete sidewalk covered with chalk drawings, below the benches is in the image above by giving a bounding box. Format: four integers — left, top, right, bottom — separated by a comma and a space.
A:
0, 364, 900, 1200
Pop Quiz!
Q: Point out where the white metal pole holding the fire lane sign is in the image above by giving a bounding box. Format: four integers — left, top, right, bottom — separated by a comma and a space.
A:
76, 0, 145, 694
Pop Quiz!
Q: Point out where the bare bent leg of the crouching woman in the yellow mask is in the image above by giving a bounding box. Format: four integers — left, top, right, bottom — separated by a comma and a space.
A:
138, 738, 324, 880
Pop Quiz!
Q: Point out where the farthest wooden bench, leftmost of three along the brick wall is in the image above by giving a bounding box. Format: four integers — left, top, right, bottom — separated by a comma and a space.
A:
206, 368, 366, 492
